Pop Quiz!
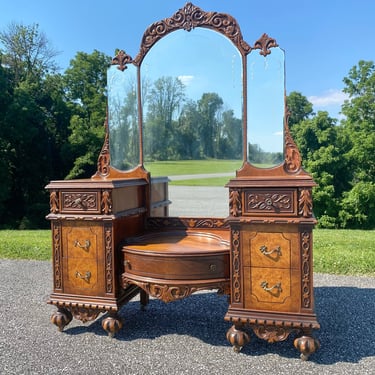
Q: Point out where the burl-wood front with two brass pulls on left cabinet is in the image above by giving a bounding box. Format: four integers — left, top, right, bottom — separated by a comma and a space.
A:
62, 222, 104, 295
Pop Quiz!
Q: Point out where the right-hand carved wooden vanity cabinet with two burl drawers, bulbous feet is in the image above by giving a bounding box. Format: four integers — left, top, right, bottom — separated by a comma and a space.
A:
225, 176, 319, 359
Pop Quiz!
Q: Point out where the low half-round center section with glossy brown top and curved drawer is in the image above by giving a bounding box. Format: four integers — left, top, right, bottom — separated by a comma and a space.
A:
122, 232, 230, 280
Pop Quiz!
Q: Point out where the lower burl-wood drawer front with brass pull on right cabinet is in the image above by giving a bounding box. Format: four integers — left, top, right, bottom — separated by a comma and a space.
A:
244, 267, 300, 312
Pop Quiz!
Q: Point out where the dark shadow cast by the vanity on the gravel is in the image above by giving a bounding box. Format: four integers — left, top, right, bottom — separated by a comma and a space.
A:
64, 287, 375, 365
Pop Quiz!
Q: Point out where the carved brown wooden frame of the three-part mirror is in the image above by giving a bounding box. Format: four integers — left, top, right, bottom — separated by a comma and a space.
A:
92, 2, 301, 180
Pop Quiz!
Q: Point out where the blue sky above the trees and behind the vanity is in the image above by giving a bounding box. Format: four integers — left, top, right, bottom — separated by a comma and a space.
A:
0, 0, 375, 117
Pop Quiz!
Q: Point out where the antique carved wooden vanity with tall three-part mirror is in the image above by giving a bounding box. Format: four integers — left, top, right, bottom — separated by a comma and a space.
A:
47, 3, 319, 359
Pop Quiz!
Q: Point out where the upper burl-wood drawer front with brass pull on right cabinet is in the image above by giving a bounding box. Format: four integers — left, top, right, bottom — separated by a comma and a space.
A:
243, 232, 299, 268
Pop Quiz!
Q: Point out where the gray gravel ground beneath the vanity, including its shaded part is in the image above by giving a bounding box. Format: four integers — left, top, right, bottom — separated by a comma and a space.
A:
0, 260, 375, 375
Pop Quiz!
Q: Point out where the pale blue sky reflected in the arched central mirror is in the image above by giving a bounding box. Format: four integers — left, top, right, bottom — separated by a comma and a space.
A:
141, 28, 242, 118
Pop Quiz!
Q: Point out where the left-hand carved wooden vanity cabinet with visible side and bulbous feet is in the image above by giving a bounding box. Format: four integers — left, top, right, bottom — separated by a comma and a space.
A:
47, 179, 152, 335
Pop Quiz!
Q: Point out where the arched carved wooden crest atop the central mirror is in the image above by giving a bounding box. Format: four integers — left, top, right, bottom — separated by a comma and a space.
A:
134, 3, 251, 65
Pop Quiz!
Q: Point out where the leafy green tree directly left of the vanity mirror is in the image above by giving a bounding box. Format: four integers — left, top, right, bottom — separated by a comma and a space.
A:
64, 50, 110, 178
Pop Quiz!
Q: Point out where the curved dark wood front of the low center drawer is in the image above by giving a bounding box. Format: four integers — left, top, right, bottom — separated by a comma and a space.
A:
124, 250, 229, 280
